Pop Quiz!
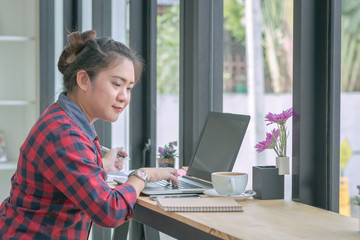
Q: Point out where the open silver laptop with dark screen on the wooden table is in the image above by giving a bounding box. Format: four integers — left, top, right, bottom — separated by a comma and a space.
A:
114, 112, 250, 195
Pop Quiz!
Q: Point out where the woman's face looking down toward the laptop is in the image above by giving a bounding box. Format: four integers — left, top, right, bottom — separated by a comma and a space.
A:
83, 58, 135, 123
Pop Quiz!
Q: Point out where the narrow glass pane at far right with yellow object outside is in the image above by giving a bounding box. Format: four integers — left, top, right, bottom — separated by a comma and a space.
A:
339, 0, 360, 217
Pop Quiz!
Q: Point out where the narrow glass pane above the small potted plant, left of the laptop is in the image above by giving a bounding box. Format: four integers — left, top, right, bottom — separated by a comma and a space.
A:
156, 0, 180, 167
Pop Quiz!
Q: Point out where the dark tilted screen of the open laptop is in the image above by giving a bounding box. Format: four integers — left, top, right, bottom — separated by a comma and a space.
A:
187, 112, 250, 181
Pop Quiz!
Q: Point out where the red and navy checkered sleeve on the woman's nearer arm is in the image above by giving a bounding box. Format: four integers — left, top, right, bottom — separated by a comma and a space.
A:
32, 128, 136, 227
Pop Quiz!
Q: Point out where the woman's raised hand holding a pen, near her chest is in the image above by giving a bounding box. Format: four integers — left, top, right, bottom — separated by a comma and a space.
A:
103, 148, 128, 173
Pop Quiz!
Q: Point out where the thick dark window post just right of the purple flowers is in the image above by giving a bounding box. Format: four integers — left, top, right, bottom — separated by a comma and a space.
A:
292, 0, 341, 212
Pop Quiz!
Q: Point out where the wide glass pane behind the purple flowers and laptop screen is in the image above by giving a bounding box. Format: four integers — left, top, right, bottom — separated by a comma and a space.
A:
223, 0, 293, 198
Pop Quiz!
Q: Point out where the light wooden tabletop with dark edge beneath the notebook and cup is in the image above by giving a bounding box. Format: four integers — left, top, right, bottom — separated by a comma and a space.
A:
133, 197, 360, 240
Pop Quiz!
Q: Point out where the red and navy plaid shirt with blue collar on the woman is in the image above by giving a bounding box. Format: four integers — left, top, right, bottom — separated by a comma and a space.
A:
0, 94, 136, 240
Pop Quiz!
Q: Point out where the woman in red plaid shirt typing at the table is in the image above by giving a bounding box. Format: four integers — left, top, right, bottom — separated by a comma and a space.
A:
0, 31, 178, 239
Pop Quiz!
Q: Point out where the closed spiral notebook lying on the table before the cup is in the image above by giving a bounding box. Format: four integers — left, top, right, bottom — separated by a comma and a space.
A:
157, 198, 243, 212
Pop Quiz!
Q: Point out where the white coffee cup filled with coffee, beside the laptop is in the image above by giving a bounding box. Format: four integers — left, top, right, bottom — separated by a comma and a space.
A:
211, 172, 248, 195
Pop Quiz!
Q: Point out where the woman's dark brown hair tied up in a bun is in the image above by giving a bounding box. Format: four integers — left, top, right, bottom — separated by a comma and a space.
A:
58, 30, 143, 92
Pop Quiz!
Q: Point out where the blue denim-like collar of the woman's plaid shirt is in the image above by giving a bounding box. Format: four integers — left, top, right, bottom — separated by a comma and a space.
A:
56, 92, 97, 141
